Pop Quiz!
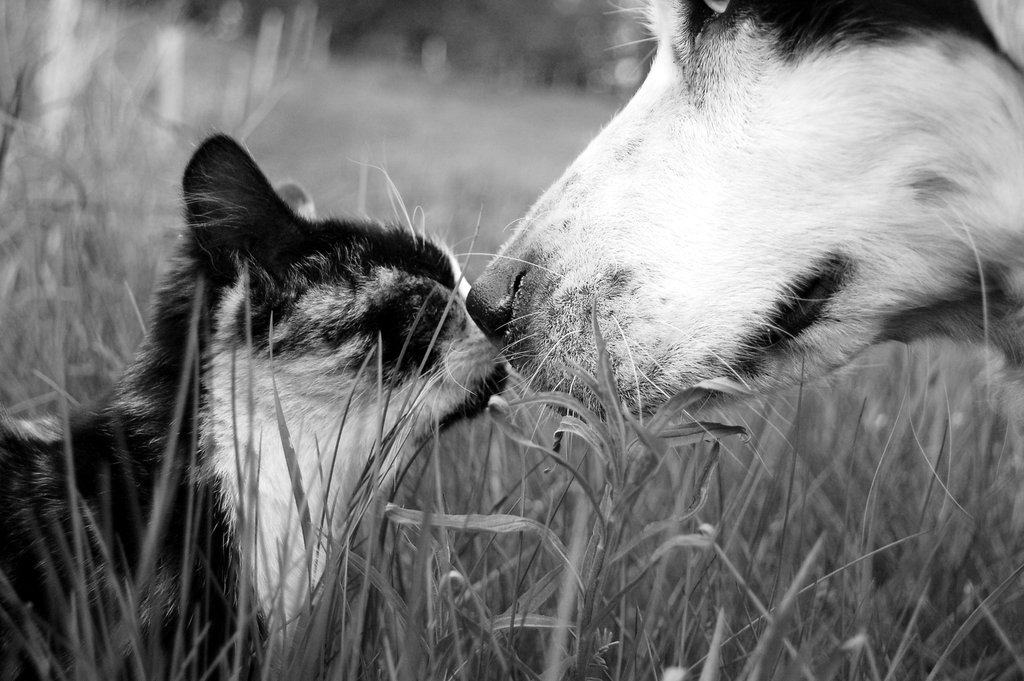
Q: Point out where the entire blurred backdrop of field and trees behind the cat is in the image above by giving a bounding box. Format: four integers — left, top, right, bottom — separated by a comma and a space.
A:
0, 0, 652, 403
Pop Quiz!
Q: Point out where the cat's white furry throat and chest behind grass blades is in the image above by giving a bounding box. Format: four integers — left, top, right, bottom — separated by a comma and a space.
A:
202, 338, 413, 629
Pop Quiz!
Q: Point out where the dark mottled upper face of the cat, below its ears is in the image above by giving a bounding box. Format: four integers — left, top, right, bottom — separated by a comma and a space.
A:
215, 219, 465, 378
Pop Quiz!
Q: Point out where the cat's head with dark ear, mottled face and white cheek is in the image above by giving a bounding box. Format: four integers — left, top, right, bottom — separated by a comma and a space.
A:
176, 135, 504, 449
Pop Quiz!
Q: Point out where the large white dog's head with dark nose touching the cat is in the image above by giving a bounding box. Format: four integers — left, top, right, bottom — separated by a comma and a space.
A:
469, 0, 1024, 410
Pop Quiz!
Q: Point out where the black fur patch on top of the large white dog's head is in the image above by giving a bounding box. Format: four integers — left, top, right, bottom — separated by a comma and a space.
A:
688, 0, 998, 57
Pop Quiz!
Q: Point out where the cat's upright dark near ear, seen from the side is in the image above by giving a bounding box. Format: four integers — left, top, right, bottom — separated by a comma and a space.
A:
182, 135, 300, 275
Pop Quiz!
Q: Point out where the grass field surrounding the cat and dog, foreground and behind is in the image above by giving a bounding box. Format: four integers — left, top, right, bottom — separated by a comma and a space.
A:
0, 5, 1024, 681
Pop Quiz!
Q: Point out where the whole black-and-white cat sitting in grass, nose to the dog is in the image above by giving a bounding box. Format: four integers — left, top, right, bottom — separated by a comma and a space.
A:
0, 136, 504, 679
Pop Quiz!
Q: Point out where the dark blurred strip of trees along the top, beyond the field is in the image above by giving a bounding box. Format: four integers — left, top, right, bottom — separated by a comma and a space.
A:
189, 0, 643, 92
